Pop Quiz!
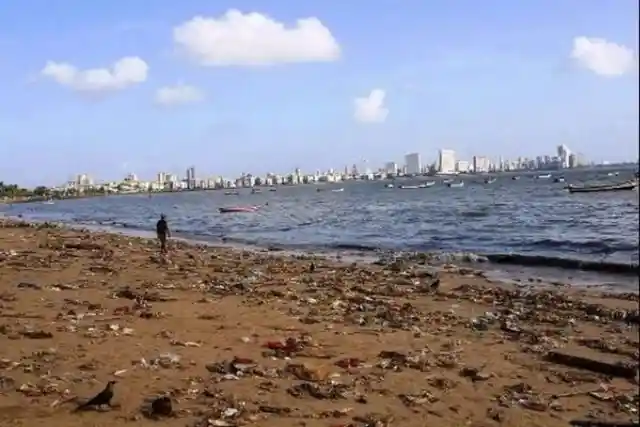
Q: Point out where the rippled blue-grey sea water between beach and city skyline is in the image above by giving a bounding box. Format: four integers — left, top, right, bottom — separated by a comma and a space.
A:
0, 169, 639, 280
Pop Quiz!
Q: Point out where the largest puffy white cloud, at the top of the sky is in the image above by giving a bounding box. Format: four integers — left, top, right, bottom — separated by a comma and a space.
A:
173, 9, 340, 66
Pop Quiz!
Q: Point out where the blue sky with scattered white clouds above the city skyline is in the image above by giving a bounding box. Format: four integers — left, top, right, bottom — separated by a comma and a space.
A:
0, 0, 639, 185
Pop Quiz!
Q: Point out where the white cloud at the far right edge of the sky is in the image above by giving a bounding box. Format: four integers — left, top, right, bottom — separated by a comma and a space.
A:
571, 37, 638, 77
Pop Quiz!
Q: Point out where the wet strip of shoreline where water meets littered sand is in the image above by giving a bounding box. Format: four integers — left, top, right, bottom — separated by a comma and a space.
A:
0, 213, 640, 292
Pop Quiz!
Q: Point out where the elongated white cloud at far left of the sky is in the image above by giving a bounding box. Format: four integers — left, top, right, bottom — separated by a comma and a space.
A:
40, 56, 149, 93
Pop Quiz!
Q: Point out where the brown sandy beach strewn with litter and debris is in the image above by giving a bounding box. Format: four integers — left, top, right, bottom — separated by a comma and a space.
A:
0, 219, 639, 427
